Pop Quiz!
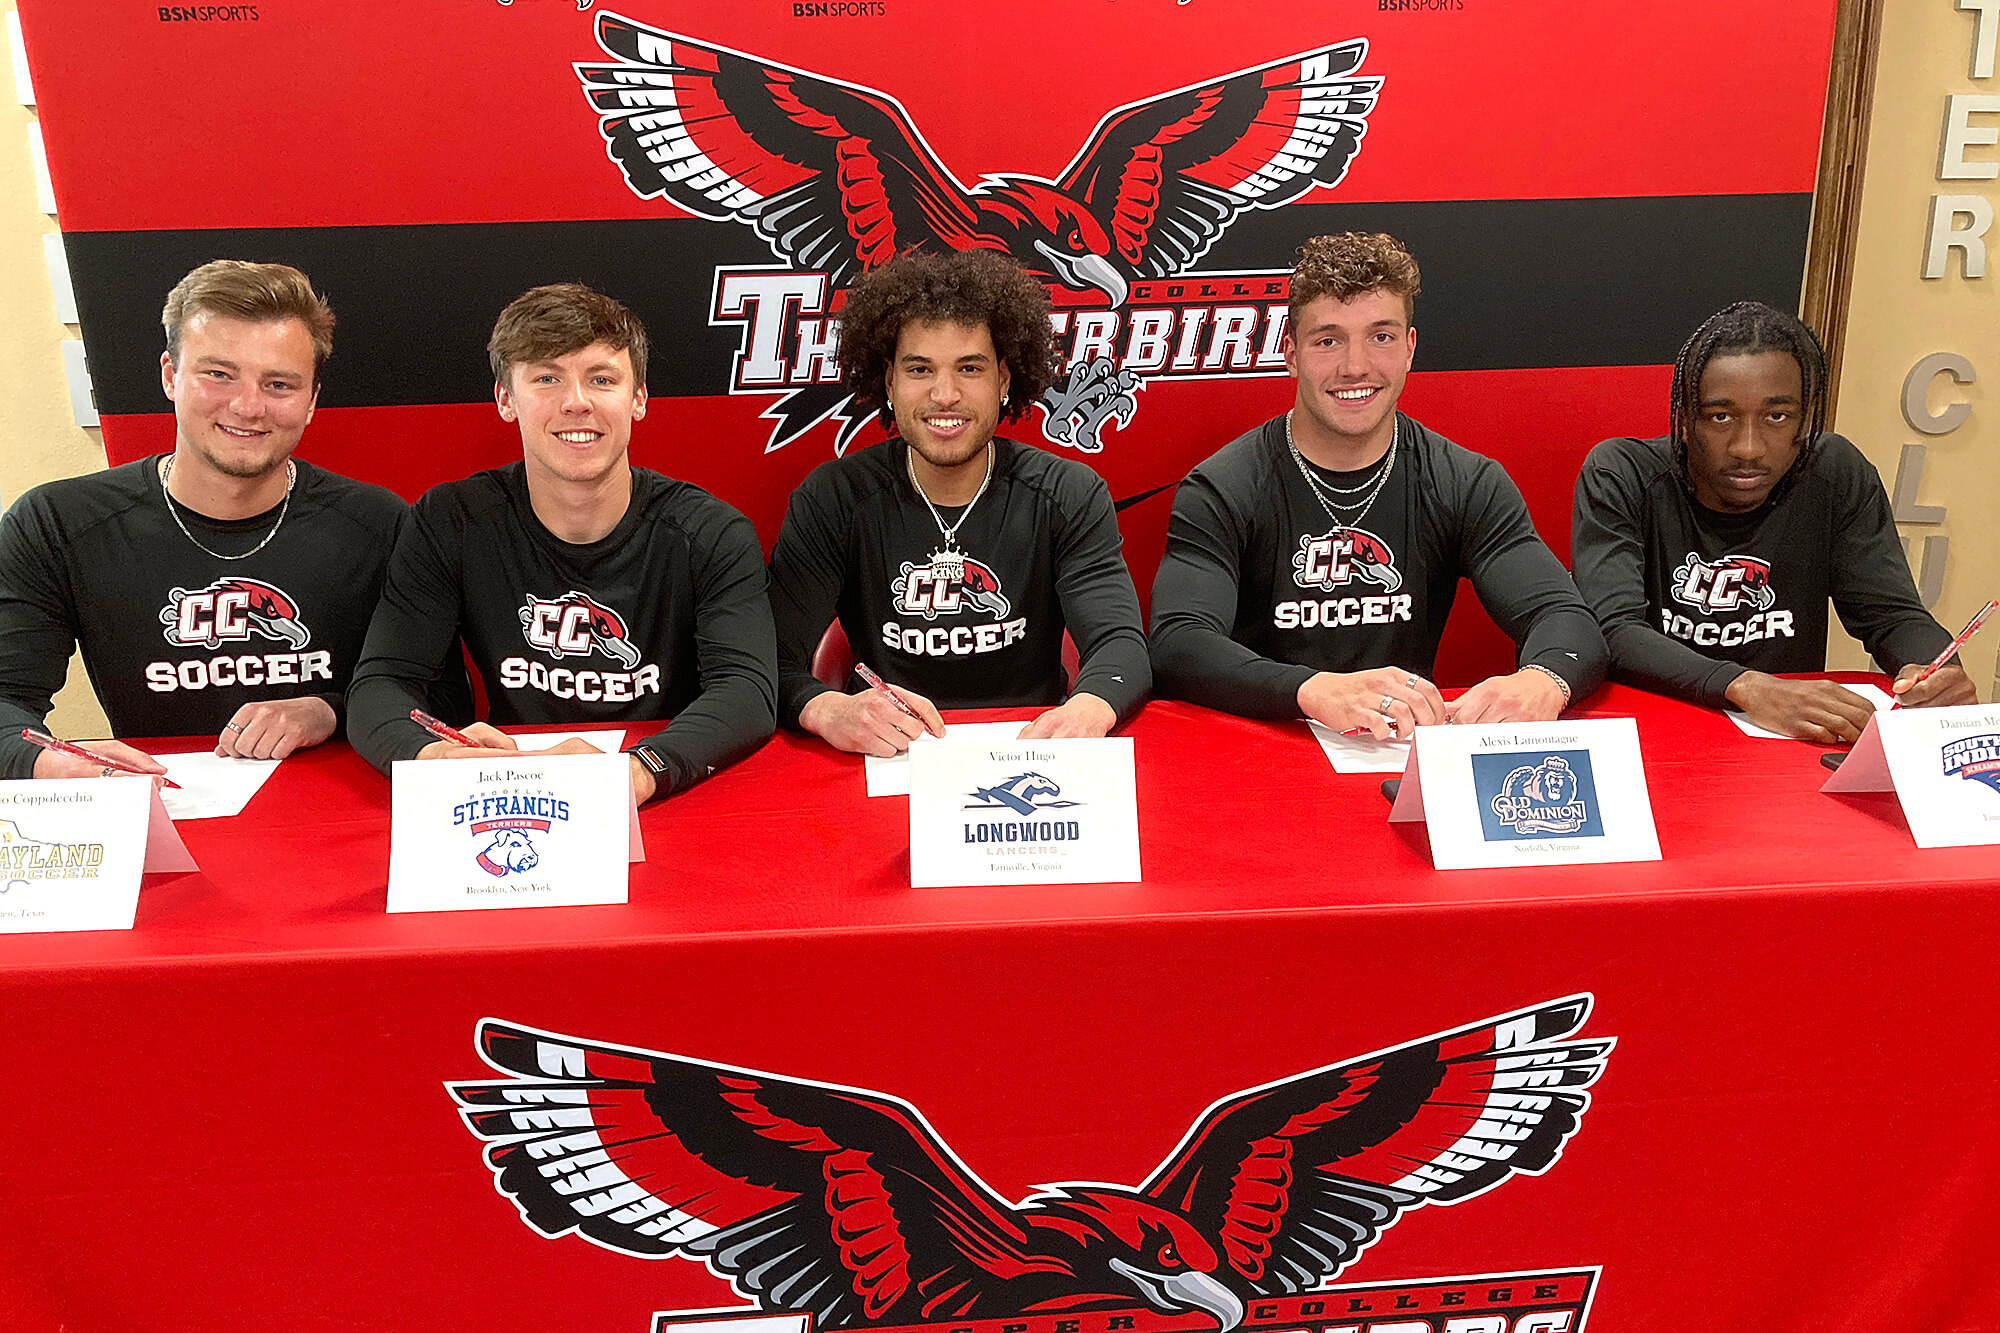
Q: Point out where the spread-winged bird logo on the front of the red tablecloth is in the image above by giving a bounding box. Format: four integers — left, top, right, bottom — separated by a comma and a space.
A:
446, 995, 1614, 1333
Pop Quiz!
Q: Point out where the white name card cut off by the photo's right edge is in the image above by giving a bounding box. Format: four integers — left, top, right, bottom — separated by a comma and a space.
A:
1820, 705, 2000, 847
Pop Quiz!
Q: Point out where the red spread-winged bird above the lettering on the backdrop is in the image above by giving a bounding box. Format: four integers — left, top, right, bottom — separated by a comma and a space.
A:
576, 14, 1382, 306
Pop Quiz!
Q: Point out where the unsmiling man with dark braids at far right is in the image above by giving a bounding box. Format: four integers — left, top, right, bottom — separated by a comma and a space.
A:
1574, 300, 1976, 743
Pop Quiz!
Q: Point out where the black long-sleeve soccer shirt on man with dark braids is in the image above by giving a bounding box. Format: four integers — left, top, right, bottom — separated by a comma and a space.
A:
1572, 434, 1952, 709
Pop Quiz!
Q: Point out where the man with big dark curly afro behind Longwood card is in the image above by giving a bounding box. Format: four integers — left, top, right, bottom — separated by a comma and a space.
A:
770, 250, 1152, 757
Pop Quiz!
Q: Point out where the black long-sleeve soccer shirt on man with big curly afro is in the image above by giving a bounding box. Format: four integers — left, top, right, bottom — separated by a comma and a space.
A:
770, 438, 1152, 727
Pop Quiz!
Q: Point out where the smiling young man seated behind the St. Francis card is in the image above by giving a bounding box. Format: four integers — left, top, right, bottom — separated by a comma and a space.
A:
348, 282, 776, 801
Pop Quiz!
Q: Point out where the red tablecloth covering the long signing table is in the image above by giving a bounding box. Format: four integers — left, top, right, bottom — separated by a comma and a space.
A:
0, 687, 2000, 1333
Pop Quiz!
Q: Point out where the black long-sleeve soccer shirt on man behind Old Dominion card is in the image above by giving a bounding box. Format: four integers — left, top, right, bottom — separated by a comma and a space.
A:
1152, 416, 1606, 717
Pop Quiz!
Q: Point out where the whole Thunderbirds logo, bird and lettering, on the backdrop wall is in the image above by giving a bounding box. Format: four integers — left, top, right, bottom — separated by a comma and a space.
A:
574, 12, 1382, 452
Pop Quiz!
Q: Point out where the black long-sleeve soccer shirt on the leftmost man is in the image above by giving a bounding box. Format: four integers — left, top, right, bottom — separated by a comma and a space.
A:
0, 456, 406, 779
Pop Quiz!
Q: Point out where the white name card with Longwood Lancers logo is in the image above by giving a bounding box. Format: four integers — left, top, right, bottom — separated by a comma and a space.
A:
910, 737, 1140, 889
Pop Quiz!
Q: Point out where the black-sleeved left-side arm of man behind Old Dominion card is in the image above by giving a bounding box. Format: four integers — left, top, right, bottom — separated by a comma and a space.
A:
1150, 476, 1312, 719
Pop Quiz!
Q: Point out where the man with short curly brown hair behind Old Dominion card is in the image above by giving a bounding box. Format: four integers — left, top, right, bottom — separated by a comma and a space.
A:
1152, 232, 1606, 737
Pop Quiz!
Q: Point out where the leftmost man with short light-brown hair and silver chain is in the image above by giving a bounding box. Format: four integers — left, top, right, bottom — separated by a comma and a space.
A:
0, 260, 404, 779
